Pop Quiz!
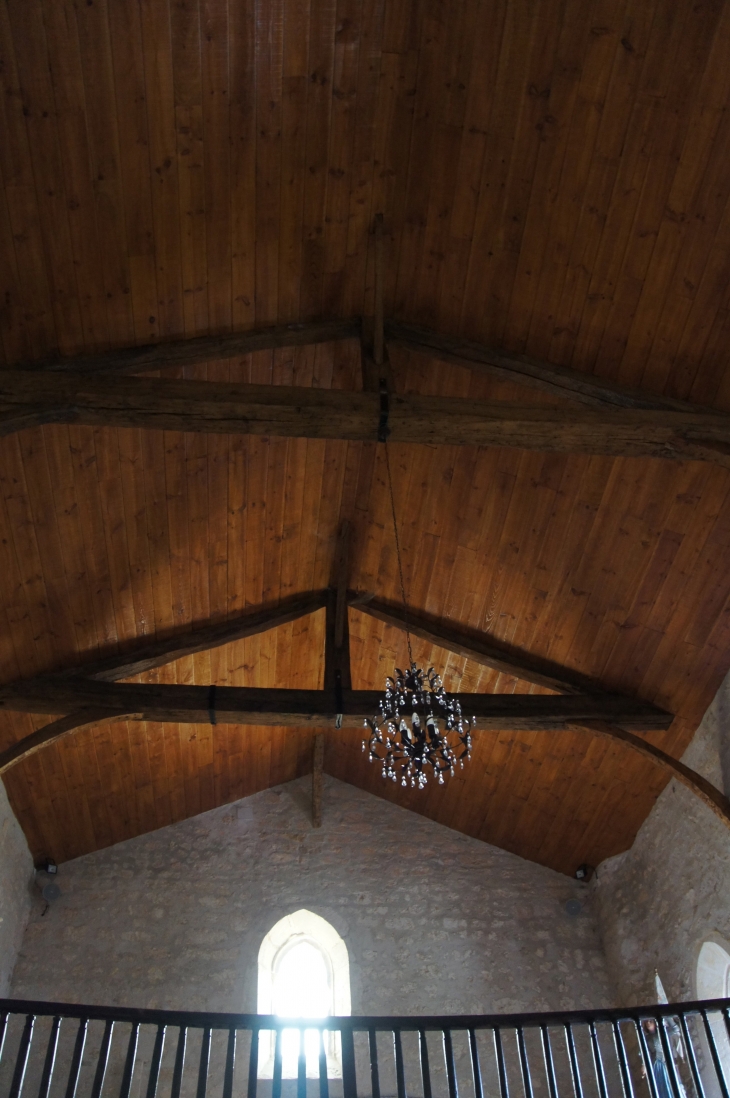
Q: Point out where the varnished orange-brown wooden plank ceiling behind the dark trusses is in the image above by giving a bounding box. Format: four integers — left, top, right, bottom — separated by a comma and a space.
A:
0, 0, 730, 873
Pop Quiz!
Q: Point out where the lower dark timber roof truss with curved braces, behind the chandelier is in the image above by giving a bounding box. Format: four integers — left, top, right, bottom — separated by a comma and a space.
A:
0, 579, 730, 826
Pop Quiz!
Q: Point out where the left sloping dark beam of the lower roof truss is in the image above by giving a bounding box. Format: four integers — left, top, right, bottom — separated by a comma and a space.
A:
55, 590, 327, 682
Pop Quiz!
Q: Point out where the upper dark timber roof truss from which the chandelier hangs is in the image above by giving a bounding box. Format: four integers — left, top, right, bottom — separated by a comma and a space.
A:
0, 317, 730, 468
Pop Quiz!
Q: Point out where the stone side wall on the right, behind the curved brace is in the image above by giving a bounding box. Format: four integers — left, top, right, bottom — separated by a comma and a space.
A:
594, 676, 730, 1004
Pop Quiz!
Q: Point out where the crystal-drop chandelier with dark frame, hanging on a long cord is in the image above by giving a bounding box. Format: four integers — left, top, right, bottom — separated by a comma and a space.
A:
362, 442, 475, 789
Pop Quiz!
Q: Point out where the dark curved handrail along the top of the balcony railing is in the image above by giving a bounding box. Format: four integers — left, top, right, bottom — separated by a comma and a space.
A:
0, 998, 730, 1032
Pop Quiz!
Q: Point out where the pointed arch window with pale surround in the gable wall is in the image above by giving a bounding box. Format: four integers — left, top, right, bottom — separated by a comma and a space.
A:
257, 908, 351, 1079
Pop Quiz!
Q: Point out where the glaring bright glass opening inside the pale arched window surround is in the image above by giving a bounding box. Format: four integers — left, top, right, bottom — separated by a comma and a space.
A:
273, 941, 332, 1078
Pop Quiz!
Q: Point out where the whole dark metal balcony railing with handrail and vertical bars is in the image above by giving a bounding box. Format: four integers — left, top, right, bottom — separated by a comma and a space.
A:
0, 999, 730, 1098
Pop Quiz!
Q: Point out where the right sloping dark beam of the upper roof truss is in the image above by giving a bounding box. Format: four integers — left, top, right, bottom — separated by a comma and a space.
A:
385, 320, 710, 414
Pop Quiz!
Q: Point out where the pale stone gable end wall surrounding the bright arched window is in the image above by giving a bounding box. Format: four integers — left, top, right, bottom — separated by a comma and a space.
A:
12, 778, 613, 1013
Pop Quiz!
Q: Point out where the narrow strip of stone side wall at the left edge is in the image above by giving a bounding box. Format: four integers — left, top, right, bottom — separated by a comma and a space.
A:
0, 782, 33, 997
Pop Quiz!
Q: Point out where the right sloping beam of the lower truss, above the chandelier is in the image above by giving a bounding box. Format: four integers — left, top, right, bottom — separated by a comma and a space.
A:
348, 591, 645, 698
